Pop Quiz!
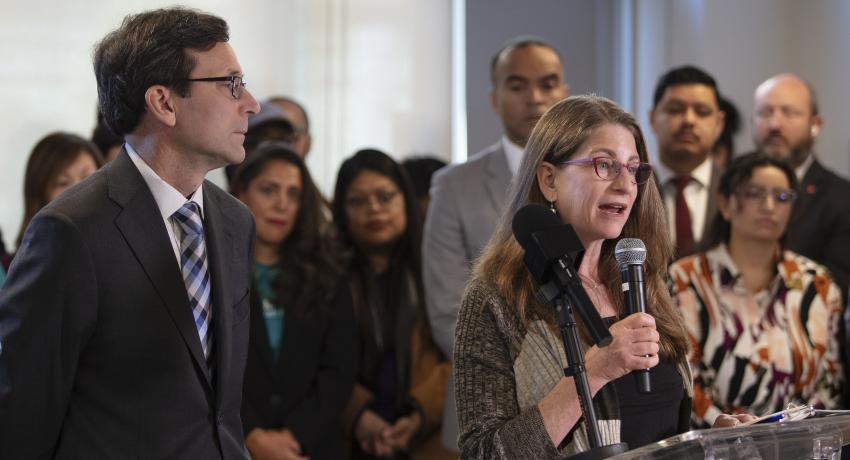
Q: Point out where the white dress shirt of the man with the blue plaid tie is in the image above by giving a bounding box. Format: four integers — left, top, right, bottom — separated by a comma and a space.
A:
124, 143, 204, 268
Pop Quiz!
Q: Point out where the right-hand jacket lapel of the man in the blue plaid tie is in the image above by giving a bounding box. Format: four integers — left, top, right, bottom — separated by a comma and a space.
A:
200, 181, 234, 404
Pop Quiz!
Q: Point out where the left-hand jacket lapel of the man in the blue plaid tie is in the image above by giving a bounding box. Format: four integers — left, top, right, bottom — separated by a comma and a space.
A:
107, 152, 211, 388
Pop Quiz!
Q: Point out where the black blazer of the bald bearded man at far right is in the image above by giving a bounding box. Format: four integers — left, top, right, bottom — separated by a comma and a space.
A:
788, 160, 850, 298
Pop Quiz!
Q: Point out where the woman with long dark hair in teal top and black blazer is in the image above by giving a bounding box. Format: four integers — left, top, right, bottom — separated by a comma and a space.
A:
231, 142, 356, 459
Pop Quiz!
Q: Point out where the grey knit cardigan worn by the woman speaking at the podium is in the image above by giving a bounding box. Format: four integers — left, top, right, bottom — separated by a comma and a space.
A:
454, 279, 693, 459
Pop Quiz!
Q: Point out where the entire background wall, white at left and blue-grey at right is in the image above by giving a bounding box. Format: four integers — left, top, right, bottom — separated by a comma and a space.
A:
0, 0, 850, 252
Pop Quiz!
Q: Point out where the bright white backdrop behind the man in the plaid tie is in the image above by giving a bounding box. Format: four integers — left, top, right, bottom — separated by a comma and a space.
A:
0, 0, 451, 252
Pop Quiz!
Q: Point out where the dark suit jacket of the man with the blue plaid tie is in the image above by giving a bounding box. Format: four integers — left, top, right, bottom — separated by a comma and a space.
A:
0, 153, 254, 459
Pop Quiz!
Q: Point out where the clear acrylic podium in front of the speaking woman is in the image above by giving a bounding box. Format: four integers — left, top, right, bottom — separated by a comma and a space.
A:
611, 415, 850, 460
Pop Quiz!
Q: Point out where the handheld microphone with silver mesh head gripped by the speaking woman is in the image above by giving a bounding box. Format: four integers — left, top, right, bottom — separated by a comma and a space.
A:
614, 238, 652, 394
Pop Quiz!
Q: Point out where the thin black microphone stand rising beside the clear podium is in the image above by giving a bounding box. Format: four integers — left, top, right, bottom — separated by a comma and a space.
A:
539, 281, 629, 460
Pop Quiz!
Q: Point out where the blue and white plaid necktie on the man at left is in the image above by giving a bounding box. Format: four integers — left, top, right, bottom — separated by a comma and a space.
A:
171, 201, 213, 365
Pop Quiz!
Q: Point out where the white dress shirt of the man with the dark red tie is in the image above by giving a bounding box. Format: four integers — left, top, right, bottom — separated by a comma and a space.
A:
654, 158, 712, 243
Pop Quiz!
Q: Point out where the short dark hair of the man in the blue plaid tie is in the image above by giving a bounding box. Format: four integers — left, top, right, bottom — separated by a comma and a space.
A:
94, 7, 230, 136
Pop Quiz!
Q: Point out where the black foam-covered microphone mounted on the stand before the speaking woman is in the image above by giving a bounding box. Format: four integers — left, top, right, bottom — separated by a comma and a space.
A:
511, 204, 611, 347
